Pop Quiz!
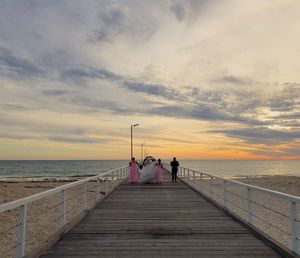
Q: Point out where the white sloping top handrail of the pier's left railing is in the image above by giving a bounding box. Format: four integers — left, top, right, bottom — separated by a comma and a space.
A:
0, 166, 128, 214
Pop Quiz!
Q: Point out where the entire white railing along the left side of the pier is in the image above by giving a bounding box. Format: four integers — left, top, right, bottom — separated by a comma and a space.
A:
0, 166, 128, 258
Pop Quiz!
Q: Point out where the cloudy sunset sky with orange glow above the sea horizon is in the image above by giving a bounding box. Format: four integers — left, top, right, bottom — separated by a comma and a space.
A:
0, 0, 300, 160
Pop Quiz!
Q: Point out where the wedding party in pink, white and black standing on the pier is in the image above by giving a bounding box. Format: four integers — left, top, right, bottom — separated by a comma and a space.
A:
128, 156, 179, 184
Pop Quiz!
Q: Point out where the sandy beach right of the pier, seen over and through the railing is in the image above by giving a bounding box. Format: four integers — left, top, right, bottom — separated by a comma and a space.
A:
192, 176, 300, 253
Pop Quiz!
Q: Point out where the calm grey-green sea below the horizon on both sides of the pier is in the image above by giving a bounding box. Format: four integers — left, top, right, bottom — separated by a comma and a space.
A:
0, 160, 300, 180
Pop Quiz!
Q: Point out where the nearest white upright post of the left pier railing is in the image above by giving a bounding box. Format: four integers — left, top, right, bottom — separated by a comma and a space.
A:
16, 204, 27, 258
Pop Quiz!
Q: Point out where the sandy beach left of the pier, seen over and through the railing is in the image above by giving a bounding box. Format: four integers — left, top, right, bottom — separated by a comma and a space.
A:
0, 178, 102, 258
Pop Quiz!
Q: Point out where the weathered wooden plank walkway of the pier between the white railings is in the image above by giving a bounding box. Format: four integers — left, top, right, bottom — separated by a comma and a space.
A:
42, 174, 281, 258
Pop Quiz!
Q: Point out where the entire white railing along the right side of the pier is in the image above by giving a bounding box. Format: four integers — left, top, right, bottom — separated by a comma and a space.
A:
165, 165, 300, 254
